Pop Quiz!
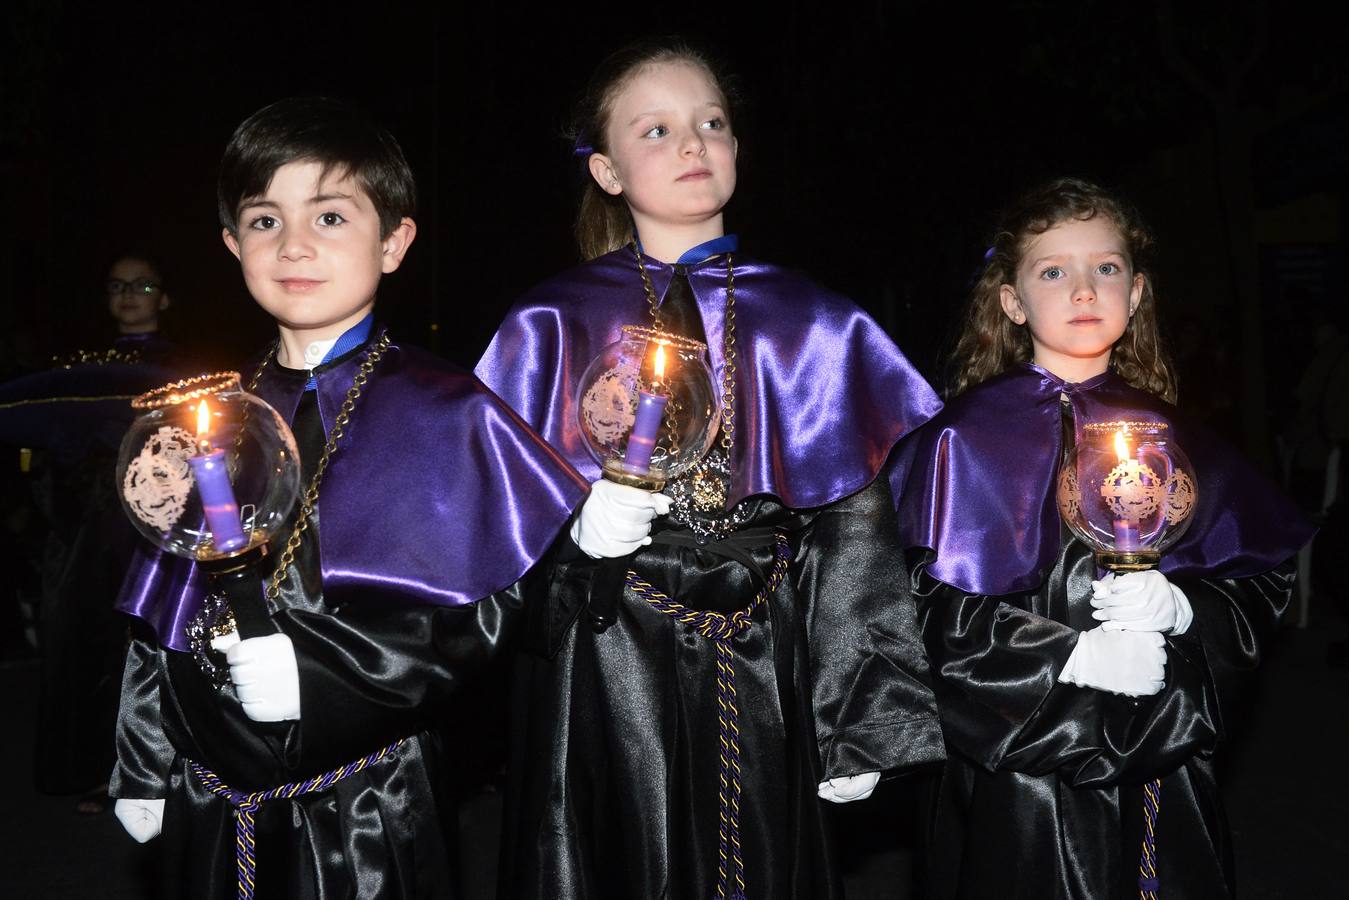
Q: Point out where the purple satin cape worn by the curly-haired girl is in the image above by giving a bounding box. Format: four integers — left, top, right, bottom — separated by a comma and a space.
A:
894, 364, 1313, 595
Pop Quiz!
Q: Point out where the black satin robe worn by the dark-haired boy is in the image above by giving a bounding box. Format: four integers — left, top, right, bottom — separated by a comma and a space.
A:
109, 383, 536, 900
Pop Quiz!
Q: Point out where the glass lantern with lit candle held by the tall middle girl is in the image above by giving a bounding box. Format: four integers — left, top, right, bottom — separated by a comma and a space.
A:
576, 325, 720, 491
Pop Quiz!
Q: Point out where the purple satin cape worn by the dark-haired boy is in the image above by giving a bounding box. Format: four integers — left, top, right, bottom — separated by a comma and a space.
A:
117, 343, 587, 650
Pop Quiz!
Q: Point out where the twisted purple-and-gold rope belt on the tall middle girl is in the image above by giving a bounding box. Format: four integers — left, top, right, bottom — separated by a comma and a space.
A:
626, 532, 792, 900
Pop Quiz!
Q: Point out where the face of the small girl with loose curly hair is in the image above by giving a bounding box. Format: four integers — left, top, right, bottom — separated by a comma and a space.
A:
1000, 216, 1144, 382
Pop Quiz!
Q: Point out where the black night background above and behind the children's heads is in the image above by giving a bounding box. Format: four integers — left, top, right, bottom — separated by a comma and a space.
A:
0, 0, 1349, 450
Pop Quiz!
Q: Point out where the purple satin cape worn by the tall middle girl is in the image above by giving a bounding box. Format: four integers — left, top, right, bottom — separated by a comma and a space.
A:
475, 248, 942, 509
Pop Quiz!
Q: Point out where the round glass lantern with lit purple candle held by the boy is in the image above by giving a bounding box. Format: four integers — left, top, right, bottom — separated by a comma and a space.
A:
117, 372, 299, 563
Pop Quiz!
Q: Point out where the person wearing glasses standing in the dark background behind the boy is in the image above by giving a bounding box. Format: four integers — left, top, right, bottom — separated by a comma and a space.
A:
0, 251, 181, 815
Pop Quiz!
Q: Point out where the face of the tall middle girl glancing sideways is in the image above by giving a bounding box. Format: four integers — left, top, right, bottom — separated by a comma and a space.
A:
590, 62, 737, 241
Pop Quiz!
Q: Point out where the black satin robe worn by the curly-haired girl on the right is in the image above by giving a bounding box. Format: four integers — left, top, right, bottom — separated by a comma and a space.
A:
911, 540, 1292, 900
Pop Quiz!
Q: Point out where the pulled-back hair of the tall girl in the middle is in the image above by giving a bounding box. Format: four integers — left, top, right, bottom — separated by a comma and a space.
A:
571, 38, 735, 259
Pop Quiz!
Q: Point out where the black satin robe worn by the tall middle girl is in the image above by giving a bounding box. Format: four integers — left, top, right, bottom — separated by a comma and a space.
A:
500, 478, 942, 900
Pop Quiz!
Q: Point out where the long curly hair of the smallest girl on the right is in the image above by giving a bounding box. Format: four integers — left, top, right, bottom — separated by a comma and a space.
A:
952, 178, 1176, 403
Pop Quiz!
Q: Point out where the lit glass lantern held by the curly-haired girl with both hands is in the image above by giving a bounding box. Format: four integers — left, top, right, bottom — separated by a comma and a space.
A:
1058, 421, 1198, 572
